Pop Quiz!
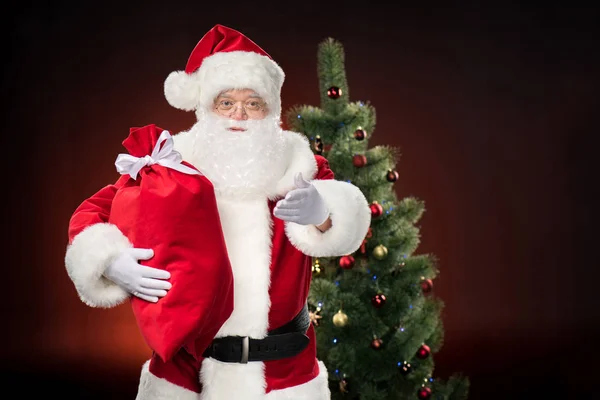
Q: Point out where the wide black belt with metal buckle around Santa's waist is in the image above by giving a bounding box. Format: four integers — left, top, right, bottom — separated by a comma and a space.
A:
202, 304, 310, 364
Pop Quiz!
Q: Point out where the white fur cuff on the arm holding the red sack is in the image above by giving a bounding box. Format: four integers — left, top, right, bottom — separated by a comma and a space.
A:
65, 223, 132, 308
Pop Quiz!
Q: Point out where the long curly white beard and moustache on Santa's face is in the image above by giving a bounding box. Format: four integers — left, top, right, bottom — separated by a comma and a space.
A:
190, 111, 289, 197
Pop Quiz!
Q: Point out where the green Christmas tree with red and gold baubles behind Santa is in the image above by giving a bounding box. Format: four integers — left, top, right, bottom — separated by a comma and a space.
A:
286, 38, 469, 400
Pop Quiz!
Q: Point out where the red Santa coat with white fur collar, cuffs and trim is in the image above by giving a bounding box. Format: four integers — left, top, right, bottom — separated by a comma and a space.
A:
65, 132, 371, 400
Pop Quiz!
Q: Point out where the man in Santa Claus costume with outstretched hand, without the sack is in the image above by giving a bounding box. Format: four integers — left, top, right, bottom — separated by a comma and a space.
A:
65, 25, 371, 400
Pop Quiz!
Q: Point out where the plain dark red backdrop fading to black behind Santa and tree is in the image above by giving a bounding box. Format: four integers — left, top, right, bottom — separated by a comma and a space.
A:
0, 1, 600, 399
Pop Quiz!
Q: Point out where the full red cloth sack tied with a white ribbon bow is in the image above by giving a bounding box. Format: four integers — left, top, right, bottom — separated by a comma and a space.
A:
109, 125, 233, 361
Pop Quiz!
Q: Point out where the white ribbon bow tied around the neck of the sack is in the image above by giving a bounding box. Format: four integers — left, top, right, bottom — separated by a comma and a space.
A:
115, 131, 202, 179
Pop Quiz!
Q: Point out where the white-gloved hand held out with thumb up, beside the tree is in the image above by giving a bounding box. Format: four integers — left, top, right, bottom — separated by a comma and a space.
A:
273, 172, 329, 226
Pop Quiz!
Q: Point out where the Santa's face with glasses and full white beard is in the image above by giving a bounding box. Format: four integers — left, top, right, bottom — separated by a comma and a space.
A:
191, 89, 288, 196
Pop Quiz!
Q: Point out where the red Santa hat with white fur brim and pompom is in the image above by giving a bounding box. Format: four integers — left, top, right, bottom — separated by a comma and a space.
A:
164, 25, 285, 117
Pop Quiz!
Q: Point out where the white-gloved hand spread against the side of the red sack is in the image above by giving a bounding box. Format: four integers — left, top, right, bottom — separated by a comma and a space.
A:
104, 248, 171, 303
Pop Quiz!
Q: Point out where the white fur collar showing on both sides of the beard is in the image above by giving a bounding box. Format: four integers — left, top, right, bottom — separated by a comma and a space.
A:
173, 130, 317, 200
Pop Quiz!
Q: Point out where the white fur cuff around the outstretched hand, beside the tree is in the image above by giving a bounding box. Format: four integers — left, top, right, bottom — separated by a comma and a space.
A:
285, 179, 371, 257
